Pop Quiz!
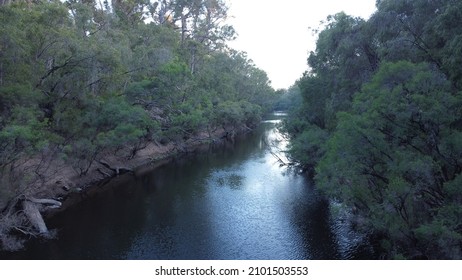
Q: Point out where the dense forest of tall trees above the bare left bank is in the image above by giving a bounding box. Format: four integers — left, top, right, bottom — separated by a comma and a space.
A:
0, 0, 276, 249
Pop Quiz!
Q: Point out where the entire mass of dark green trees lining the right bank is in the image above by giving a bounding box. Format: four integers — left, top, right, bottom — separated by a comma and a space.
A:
285, 0, 462, 259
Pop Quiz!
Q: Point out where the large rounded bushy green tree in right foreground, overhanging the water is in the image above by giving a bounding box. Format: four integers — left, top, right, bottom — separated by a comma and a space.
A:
316, 61, 461, 256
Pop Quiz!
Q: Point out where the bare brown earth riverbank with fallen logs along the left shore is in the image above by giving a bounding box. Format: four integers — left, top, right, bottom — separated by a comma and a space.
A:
0, 126, 250, 251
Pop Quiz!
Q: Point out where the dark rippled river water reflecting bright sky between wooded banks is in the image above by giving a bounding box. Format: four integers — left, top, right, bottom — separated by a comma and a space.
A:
0, 114, 369, 260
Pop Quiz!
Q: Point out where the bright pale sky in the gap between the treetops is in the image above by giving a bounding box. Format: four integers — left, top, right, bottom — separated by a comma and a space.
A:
227, 0, 375, 89
